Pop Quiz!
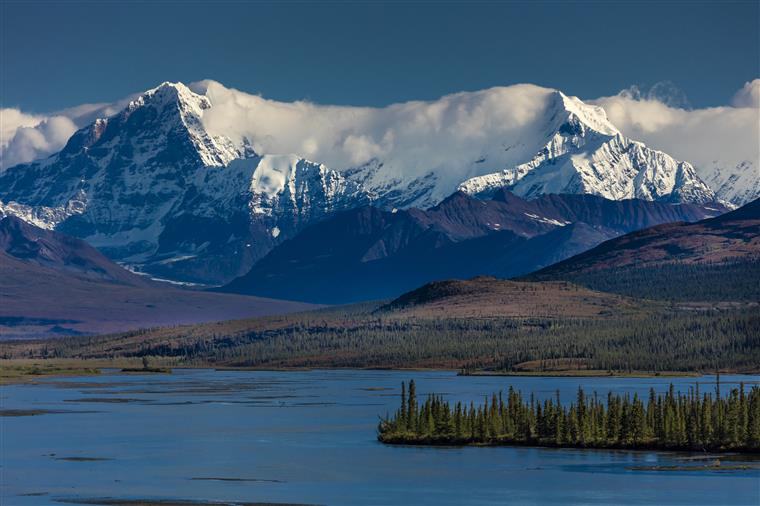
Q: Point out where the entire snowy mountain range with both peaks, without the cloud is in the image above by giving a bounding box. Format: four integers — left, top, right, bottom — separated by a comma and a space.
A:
0, 83, 732, 283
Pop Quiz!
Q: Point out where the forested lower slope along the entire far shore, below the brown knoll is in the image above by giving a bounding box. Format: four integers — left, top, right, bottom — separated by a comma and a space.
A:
16, 304, 760, 373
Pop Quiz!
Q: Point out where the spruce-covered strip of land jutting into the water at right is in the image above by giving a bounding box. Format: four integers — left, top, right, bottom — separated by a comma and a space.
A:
378, 381, 760, 453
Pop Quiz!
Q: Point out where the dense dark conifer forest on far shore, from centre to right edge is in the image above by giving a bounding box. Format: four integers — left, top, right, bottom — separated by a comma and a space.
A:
203, 310, 760, 372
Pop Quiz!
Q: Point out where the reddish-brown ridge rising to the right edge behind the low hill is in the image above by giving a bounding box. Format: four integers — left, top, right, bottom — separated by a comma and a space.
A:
525, 199, 760, 302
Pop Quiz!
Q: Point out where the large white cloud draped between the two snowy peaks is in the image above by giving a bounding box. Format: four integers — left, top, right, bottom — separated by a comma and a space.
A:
191, 81, 553, 200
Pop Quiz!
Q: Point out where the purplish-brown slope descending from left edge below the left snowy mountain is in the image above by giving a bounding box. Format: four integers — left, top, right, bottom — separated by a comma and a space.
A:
0, 217, 314, 340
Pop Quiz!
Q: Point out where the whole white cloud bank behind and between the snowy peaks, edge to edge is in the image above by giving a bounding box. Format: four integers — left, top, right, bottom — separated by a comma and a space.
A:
0, 79, 760, 186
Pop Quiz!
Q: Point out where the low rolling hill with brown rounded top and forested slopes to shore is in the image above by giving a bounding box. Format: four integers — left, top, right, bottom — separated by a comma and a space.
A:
0, 278, 760, 374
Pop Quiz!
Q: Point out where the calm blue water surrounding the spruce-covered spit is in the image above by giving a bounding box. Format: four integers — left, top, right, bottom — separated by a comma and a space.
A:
0, 370, 760, 506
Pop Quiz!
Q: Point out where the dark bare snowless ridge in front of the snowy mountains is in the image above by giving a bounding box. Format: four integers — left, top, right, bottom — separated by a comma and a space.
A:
222, 190, 725, 303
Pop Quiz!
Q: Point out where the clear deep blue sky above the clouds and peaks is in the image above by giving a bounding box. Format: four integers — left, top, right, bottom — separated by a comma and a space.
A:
0, 0, 760, 112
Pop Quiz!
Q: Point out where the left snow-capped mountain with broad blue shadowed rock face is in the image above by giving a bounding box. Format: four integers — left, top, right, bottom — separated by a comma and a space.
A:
0, 83, 366, 281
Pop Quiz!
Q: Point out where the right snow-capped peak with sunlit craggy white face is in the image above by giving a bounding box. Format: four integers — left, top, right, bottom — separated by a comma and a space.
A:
459, 92, 716, 203
